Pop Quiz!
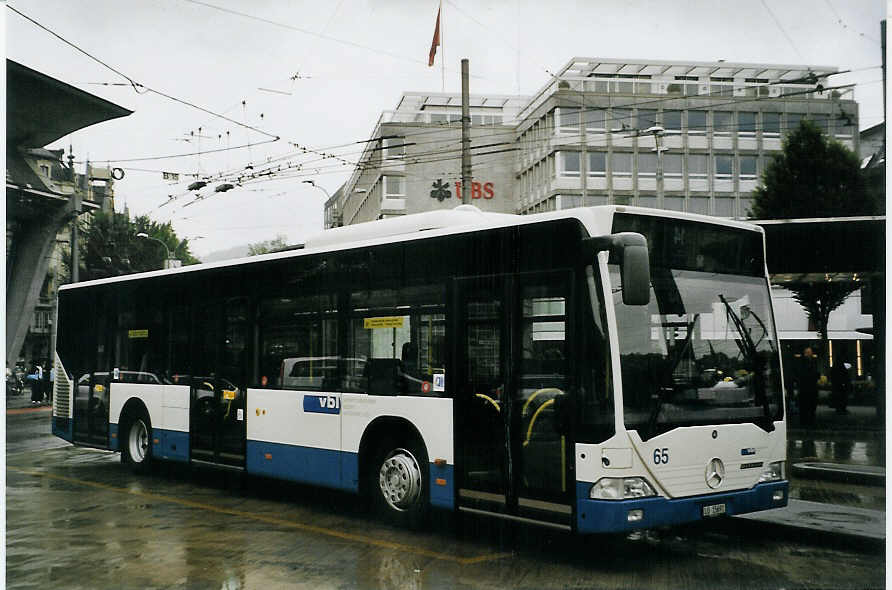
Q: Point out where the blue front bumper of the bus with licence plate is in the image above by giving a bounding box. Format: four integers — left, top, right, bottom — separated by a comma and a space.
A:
576, 481, 790, 533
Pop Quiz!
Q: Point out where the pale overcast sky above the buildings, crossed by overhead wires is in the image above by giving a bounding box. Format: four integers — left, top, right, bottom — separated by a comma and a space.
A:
4, 0, 886, 256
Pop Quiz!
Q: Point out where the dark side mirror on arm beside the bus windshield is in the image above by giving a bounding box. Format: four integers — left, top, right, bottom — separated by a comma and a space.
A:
584, 232, 650, 305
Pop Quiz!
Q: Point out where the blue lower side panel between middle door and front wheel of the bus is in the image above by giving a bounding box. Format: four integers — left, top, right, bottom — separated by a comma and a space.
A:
245, 440, 359, 492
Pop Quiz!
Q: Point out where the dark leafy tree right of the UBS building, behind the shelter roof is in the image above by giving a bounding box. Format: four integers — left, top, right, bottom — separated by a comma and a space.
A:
752, 120, 878, 369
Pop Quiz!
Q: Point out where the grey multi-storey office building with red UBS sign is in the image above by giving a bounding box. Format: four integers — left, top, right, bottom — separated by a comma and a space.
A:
326, 57, 858, 227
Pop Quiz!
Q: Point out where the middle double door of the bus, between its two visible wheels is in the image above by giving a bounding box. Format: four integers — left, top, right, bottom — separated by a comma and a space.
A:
189, 297, 248, 468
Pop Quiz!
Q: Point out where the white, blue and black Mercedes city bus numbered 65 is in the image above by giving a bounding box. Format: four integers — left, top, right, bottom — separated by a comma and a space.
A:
52, 205, 788, 533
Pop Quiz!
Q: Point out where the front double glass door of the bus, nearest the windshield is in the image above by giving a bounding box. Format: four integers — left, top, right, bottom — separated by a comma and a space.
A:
451, 272, 574, 526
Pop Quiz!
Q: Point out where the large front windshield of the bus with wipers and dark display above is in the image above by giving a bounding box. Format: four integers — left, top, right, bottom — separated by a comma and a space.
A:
608, 214, 783, 439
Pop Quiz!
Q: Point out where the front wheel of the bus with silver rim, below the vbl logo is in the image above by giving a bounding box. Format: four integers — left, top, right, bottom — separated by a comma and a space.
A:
367, 441, 430, 528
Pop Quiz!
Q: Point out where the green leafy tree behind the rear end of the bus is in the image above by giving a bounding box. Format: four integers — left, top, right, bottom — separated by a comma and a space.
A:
65, 211, 199, 280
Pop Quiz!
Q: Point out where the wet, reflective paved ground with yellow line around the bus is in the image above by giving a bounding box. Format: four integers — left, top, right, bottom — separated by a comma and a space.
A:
6, 409, 885, 589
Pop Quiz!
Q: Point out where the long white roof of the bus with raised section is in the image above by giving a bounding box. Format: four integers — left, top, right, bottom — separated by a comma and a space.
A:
59, 205, 764, 291
